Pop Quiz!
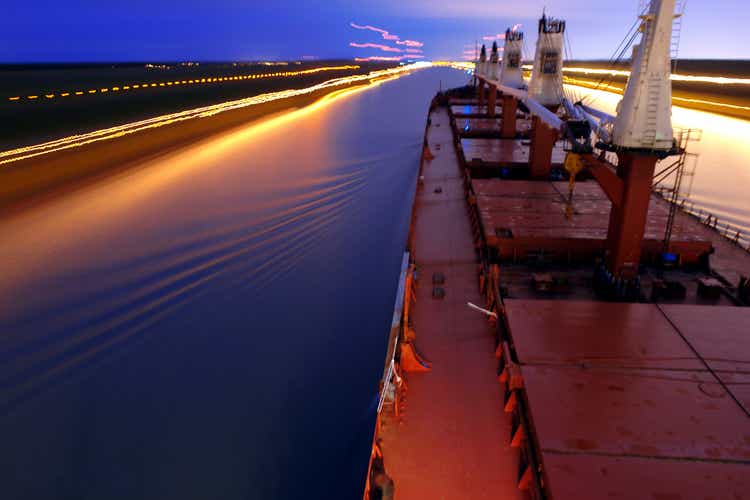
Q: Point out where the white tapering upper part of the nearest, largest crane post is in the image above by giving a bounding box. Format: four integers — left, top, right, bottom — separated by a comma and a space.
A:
612, 0, 675, 150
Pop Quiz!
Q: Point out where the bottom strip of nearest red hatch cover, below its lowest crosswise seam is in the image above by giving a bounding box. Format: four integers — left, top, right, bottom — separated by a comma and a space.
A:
544, 453, 750, 500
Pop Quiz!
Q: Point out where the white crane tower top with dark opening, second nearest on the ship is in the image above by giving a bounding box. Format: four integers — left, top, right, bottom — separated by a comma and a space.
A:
529, 14, 565, 107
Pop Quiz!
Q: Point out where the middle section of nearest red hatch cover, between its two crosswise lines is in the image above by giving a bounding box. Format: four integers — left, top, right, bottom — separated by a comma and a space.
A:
522, 365, 750, 461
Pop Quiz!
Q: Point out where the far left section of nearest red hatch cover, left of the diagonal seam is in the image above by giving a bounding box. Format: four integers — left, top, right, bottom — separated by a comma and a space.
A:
506, 300, 704, 370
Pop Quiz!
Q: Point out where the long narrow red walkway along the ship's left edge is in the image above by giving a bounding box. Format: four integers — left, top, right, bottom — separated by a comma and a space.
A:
380, 108, 521, 499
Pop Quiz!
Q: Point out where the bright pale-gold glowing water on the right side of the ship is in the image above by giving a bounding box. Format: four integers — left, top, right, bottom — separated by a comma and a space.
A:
566, 85, 750, 234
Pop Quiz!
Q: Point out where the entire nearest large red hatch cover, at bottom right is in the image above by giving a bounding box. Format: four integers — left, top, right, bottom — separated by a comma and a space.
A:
505, 300, 750, 498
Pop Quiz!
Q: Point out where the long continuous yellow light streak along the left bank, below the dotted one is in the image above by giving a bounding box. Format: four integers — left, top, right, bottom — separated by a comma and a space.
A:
0, 62, 431, 165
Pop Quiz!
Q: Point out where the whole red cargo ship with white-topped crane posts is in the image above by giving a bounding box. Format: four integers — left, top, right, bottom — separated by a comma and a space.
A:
364, 0, 750, 500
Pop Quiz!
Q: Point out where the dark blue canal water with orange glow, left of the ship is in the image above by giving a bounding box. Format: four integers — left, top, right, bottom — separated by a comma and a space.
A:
0, 69, 466, 500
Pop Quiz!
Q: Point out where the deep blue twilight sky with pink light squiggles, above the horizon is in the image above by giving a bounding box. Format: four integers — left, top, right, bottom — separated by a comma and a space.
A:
0, 0, 750, 63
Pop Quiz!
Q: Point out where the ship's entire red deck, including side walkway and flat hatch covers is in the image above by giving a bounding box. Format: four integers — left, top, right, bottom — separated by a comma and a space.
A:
379, 94, 750, 500
